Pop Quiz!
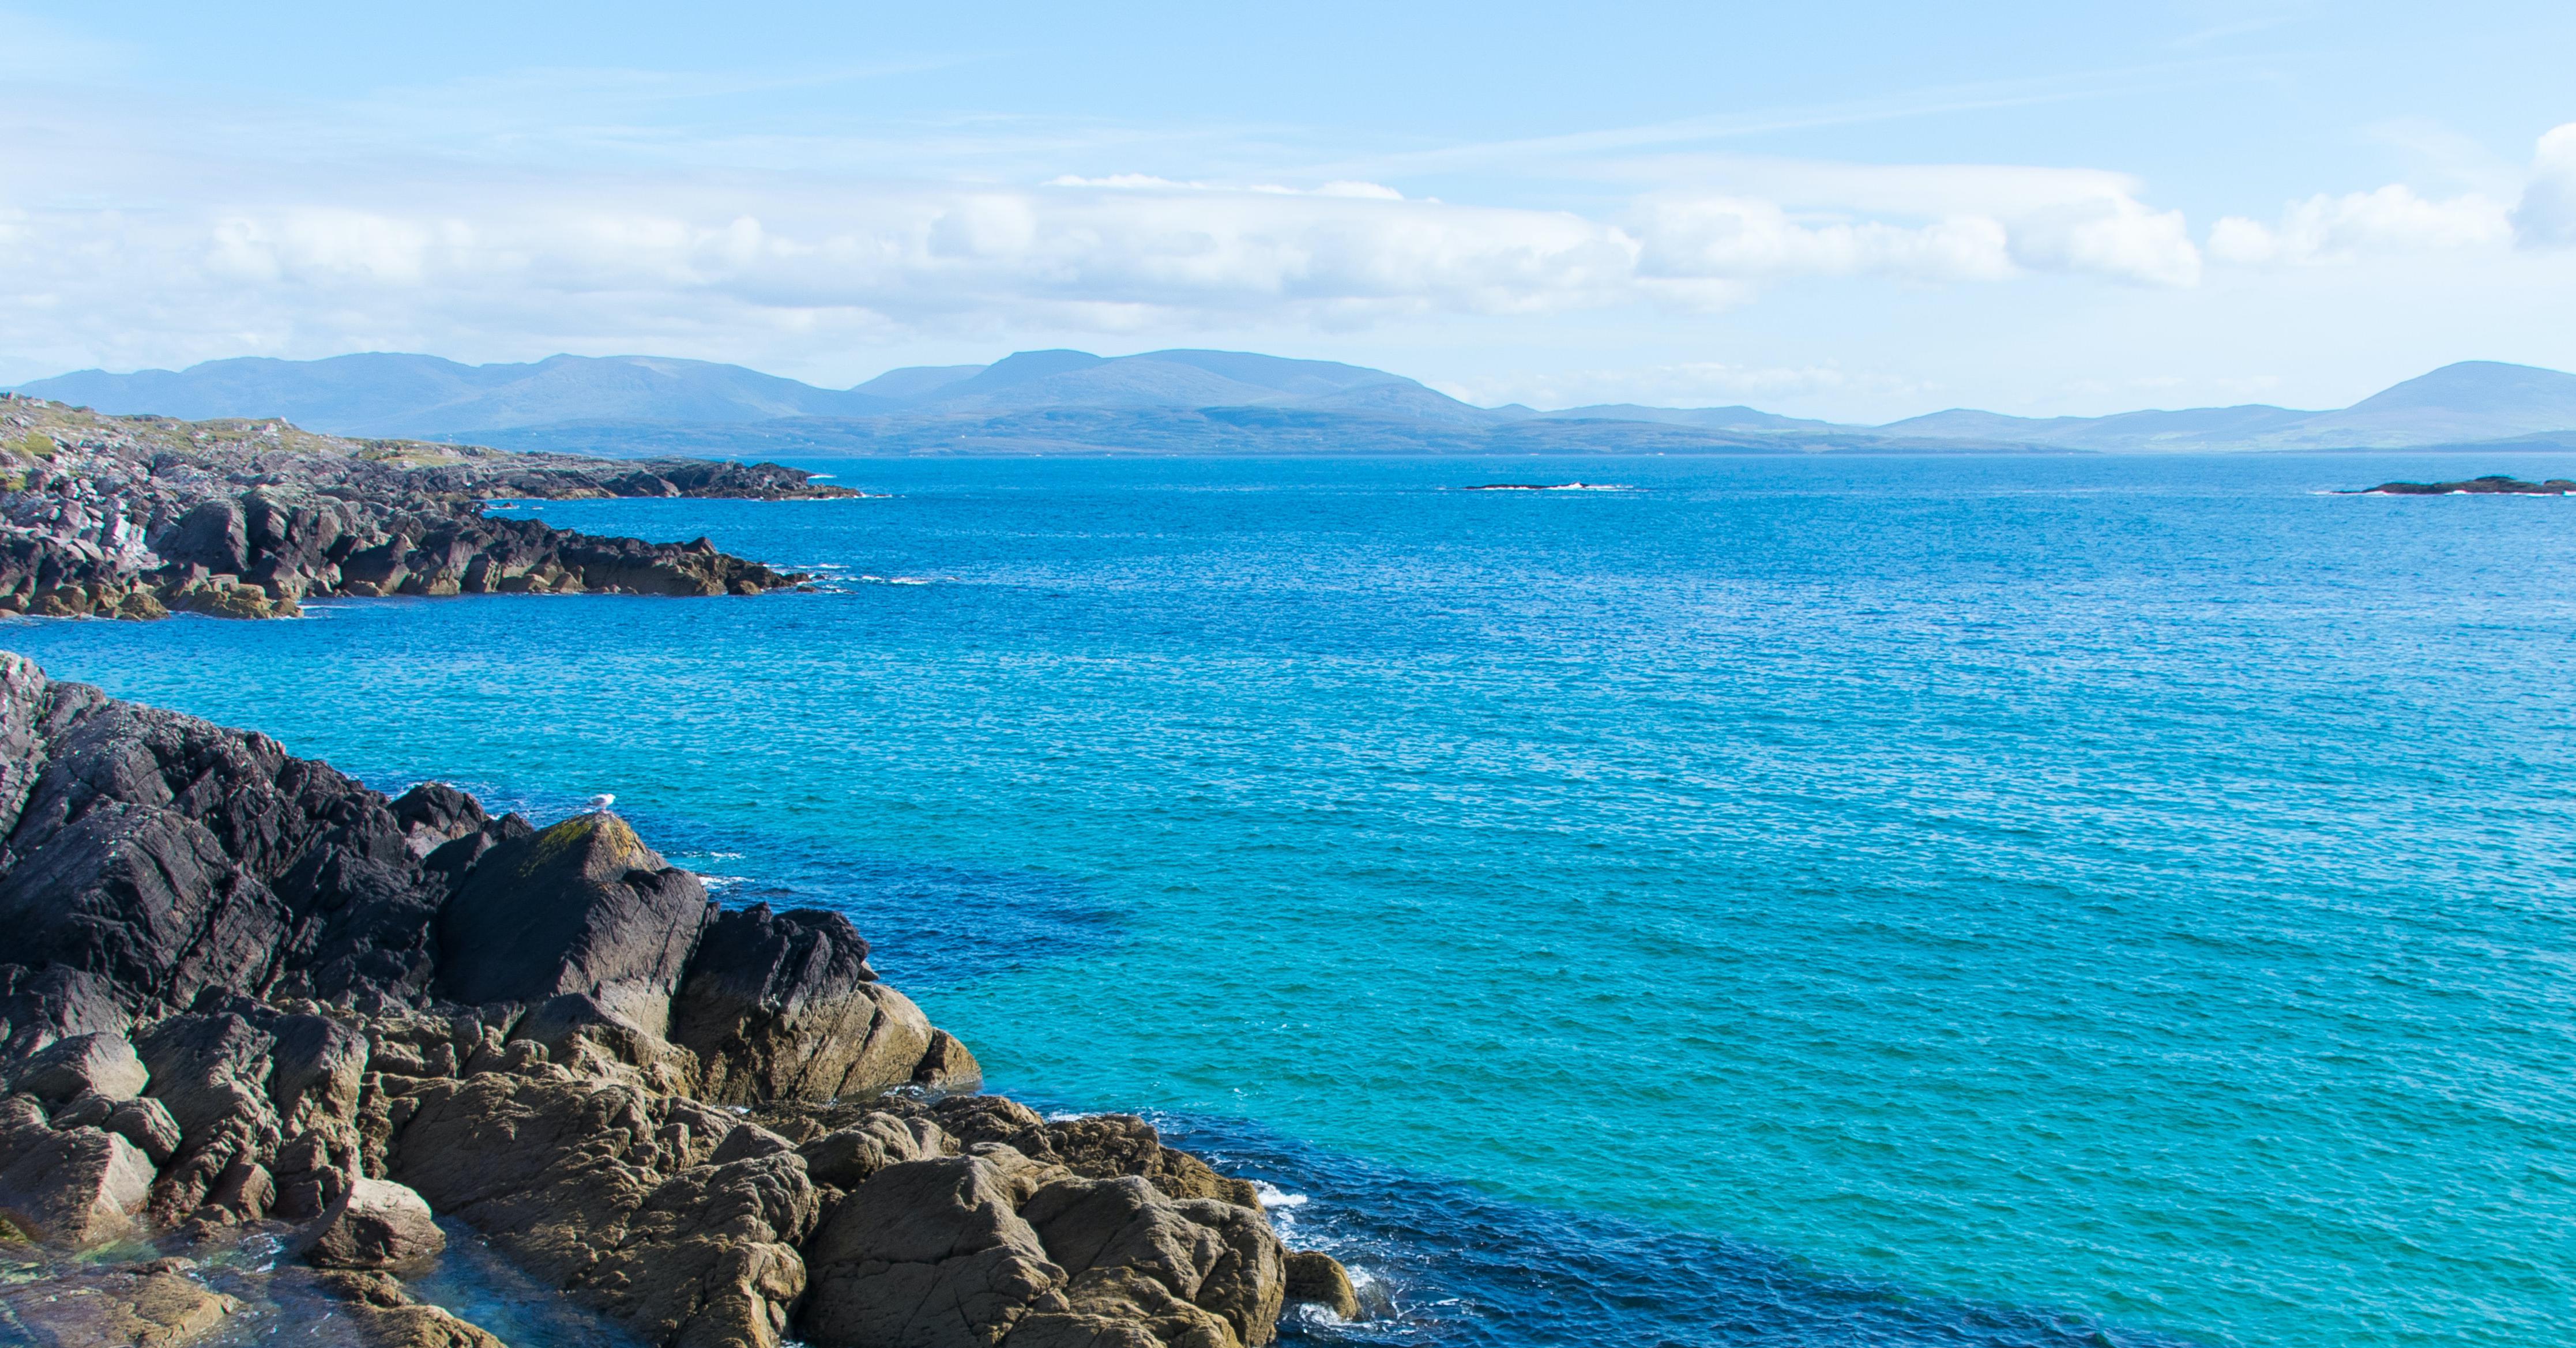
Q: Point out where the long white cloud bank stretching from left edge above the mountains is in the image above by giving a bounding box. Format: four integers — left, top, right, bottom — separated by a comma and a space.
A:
0, 163, 2200, 376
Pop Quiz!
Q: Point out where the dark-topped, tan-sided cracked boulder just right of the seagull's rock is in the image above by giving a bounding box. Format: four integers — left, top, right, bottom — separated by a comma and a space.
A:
670, 905, 930, 1103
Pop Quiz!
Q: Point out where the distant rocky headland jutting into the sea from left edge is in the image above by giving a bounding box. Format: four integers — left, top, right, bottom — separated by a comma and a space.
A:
0, 394, 858, 619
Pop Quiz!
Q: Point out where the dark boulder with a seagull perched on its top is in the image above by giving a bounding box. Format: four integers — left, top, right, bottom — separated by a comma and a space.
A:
438, 812, 708, 1031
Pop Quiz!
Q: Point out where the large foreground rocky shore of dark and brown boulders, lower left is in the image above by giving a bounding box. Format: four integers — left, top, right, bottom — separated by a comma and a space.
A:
0, 654, 1357, 1348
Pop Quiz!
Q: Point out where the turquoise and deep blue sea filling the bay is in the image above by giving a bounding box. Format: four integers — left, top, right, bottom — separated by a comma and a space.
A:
0, 454, 2576, 1348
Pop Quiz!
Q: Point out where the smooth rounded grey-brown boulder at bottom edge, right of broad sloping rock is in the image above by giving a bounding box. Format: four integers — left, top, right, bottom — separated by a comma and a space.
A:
796, 1157, 1071, 1348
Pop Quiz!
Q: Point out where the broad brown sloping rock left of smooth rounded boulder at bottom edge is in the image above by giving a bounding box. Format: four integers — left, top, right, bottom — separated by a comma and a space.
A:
392, 1075, 819, 1348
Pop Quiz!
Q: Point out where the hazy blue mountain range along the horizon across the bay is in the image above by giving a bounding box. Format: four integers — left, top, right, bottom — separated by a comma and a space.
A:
13, 351, 2576, 456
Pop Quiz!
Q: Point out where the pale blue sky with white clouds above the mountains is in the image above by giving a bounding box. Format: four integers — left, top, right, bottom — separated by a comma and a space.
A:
0, 0, 2576, 423
